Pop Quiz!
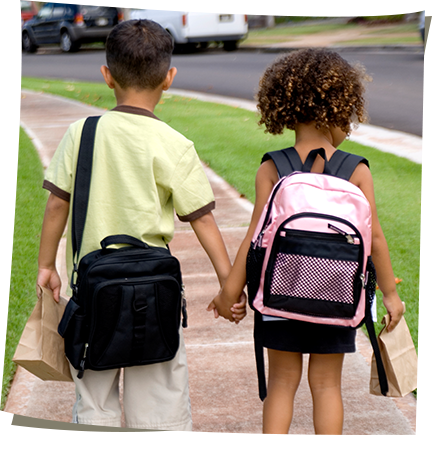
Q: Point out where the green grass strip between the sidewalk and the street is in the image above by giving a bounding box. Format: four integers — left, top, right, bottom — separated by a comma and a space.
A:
0, 75, 427, 410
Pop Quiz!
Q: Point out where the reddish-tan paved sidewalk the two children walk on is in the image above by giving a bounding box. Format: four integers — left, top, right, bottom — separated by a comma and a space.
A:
0, 87, 427, 441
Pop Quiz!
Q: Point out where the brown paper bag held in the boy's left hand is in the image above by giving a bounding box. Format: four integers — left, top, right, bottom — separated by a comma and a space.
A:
12, 286, 73, 381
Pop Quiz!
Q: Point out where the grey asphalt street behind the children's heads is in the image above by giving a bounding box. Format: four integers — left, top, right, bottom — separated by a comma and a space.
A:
0, 48, 427, 137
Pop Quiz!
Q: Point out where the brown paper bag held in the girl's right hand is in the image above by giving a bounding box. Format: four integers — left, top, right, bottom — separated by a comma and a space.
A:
370, 314, 425, 397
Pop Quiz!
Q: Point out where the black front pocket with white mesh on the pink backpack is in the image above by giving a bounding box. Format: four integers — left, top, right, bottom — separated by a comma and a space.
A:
264, 225, 362, 318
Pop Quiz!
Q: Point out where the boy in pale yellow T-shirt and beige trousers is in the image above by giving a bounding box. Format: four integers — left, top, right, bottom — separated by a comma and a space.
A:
37, 20, 246, 440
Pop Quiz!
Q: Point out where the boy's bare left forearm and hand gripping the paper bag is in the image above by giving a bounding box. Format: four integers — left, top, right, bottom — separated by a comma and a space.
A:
37, 194, 69, 302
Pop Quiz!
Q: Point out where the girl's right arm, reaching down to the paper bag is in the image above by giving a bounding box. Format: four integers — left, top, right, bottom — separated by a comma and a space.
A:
350, 164, 404, 331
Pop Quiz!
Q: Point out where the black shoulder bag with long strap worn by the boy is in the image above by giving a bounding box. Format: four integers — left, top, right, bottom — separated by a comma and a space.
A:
58, 117, 187, 378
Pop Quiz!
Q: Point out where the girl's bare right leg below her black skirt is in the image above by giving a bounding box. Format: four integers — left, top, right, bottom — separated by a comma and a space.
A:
308, 353, 344, 440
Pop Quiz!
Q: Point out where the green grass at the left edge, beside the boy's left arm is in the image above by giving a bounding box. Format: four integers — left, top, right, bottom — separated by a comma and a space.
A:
0, 111, 47, 411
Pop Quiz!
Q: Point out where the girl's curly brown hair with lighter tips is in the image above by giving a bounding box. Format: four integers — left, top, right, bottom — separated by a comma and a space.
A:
257, 48, 370, 134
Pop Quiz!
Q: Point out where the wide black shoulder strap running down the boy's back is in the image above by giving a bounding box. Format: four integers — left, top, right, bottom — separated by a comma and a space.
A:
71, 116, 99, 288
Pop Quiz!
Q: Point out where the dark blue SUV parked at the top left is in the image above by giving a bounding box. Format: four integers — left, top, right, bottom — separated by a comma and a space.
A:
21, 0, 123, 53
